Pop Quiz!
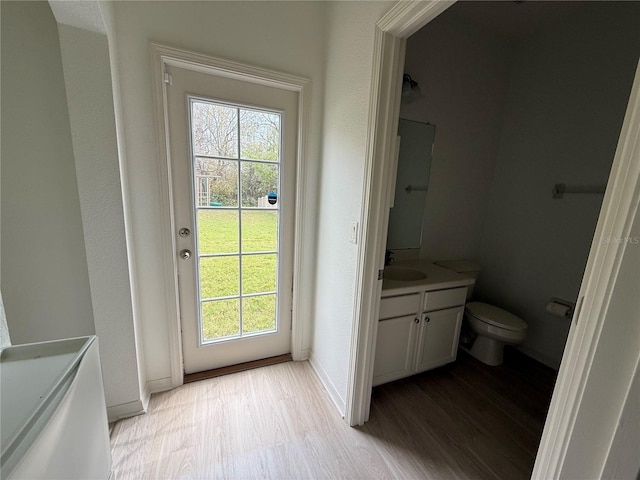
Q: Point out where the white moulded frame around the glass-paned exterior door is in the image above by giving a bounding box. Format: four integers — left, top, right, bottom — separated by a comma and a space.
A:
150, 43, 308, 387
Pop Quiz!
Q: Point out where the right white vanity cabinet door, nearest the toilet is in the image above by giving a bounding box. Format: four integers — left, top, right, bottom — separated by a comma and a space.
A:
415, 307, 464, 373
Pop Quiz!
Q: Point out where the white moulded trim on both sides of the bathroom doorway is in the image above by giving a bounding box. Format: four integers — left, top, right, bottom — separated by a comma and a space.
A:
346, 1, 640, 478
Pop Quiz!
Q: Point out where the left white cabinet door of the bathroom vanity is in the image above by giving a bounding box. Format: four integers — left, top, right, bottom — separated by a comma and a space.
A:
373, 314, 418, 386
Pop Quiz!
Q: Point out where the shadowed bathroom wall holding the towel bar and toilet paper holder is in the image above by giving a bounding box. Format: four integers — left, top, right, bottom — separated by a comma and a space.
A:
476, 2, 640, 368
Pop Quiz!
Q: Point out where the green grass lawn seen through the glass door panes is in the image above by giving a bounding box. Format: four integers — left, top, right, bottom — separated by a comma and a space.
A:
198, 210, 278, 340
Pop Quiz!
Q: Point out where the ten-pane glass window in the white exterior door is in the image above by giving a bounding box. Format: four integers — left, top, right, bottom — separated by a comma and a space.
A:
191, 98, 281, 343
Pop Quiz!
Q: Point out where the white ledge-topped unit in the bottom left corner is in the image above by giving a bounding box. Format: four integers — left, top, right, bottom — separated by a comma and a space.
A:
0, 336, 111, 480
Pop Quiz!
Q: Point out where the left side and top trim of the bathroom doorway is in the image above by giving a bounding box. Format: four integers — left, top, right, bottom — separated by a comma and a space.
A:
345, 1, 453, 426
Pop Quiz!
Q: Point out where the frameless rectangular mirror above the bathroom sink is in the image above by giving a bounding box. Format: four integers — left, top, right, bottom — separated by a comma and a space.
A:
387, 118, 436, 250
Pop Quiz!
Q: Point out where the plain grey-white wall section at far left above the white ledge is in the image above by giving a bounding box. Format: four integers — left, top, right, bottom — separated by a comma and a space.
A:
0, 1, 94, 344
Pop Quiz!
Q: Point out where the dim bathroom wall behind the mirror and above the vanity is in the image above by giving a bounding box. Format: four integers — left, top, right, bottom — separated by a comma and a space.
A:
400, 11, 512, 260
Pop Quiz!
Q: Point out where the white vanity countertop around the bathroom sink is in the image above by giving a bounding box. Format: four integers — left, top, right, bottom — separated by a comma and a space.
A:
382, 260, 475, 297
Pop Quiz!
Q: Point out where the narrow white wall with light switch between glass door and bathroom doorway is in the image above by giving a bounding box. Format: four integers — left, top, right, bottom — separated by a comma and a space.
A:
311, 2, 392, 413
